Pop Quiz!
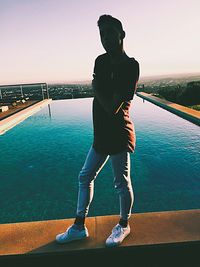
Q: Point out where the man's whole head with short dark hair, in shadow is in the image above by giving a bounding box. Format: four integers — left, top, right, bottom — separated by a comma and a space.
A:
97, 15, 125, 53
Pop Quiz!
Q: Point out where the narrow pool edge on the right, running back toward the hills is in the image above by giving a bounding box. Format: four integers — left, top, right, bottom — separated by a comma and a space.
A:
136, 92, 200, 125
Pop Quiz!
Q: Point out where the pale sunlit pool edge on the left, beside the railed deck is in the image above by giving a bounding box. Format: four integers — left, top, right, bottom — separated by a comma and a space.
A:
0, 99, 52, 135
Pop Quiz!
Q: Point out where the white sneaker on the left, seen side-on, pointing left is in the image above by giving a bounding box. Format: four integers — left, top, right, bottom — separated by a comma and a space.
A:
56, 224, 89, 244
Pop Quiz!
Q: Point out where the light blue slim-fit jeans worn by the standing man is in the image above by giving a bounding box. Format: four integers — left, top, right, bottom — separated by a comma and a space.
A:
76, 146, 134, 220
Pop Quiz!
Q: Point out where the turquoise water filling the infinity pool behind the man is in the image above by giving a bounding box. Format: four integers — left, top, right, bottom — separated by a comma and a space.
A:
0, 95, 200, 223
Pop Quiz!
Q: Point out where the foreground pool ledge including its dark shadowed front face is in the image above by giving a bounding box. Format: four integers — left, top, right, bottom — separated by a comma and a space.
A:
0, 210, 200, 266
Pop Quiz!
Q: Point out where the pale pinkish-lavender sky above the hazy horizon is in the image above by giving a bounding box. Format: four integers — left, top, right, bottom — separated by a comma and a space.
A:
0, 0, 200, 84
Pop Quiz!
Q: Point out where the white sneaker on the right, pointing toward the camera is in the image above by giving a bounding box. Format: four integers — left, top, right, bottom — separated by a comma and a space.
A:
106, 224, 131, 247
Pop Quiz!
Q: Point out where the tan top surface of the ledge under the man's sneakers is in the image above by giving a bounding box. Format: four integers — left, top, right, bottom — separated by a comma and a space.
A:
0, 209, 200, 256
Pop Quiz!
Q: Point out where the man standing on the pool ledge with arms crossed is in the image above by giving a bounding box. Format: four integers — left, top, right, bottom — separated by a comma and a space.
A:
56, 15, 139, 246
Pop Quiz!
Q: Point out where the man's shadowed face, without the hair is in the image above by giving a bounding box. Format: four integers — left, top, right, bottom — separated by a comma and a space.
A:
99, 24, 122, 54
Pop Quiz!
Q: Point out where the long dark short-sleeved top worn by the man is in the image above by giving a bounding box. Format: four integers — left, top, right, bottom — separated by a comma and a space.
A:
92, 53, 139, 155
